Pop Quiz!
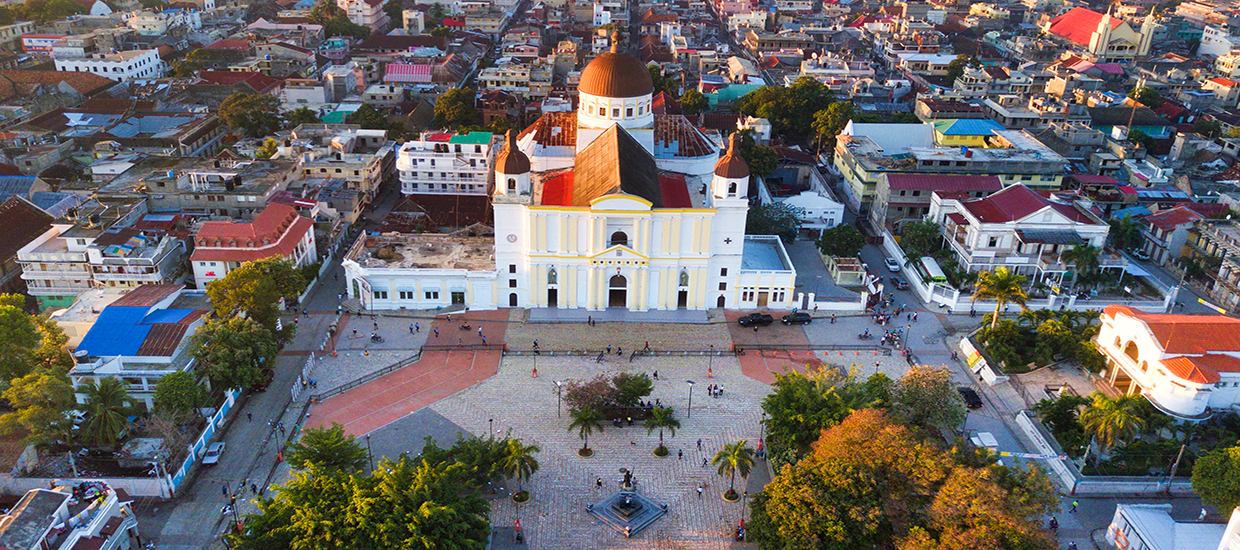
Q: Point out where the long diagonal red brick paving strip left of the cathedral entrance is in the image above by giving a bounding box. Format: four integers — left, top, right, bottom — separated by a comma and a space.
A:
306, 310, 508, 435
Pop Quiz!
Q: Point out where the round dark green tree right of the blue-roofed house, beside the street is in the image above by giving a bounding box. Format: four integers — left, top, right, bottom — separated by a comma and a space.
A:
190, 317, 279, 389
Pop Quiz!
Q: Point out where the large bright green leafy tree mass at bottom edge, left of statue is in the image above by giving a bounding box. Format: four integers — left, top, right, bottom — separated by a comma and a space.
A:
228, 458, 491, 550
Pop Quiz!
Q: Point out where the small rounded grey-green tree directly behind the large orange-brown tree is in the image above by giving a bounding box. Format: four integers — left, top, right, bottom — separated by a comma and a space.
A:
892, 365, 966, 430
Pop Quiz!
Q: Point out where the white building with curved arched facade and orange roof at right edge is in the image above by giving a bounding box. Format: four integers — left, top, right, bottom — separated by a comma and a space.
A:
1096, 305, 1240, 421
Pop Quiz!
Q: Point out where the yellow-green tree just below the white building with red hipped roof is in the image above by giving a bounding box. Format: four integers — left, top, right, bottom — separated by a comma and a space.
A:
207, 258, 306, 337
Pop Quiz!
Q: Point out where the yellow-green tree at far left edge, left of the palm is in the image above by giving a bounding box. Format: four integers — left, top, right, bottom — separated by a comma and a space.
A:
0, 369, 74, 445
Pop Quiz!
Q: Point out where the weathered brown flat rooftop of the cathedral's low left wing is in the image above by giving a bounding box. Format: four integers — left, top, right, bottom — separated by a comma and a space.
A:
348, 233, 495, 271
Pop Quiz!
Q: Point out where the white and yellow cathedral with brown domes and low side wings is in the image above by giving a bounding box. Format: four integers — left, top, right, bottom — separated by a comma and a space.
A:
342, 41, 807, 313
